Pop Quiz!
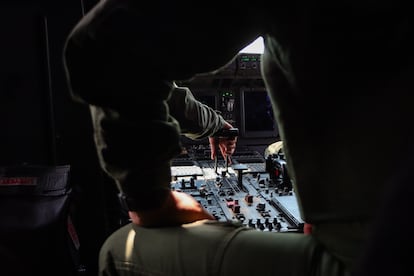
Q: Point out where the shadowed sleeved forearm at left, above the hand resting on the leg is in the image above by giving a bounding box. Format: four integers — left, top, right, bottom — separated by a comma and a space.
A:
90, 106, 181, 210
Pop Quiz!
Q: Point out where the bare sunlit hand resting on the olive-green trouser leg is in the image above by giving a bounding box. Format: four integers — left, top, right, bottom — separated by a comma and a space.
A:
128, 191, 215, 227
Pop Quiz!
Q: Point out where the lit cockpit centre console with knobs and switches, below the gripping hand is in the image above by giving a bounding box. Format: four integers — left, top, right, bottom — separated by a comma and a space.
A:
171, 146, 303, 232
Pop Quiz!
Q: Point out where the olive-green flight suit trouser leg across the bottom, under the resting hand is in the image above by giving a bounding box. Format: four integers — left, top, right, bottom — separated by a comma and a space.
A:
99, 220, 349, 276
